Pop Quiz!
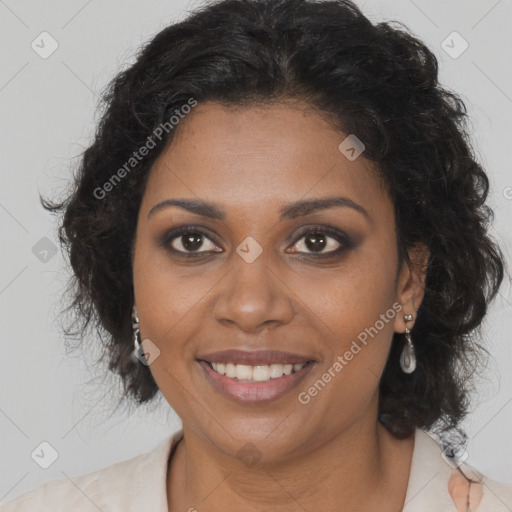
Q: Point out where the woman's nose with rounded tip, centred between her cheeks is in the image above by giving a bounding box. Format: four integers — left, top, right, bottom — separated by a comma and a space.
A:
214, 254, 294, 332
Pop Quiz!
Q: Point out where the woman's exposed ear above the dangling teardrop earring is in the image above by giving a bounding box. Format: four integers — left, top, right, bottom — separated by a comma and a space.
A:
394, 244, 430, 332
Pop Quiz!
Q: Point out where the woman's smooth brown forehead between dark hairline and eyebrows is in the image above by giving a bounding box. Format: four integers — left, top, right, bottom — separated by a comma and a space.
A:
141, 102, 389, 219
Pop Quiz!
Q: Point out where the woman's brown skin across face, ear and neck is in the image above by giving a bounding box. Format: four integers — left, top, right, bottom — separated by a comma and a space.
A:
133, 101, 428, 512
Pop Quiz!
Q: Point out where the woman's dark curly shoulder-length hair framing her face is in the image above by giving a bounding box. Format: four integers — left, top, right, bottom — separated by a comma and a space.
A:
41, 0, 504, 437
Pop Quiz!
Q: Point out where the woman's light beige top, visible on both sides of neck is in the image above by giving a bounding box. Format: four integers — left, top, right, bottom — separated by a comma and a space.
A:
0, 429, 512, 512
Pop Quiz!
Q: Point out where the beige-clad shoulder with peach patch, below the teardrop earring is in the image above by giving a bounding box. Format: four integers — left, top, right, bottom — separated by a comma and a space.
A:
404, 430, 512, 512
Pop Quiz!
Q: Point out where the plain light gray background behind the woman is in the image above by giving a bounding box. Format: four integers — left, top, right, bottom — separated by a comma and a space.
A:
0, 0, 512, 502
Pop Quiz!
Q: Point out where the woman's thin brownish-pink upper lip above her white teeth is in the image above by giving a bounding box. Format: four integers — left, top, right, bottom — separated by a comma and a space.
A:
197, 349, 313, 366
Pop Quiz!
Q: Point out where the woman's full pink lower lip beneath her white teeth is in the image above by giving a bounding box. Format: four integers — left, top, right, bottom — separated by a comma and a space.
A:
198, 361, 315, 404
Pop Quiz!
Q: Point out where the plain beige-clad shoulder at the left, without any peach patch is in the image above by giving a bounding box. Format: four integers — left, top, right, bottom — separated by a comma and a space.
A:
0, 430, 182, 512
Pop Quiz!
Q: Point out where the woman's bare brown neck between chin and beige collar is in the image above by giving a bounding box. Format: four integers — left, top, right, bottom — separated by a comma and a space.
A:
167, 421, 414, 512
